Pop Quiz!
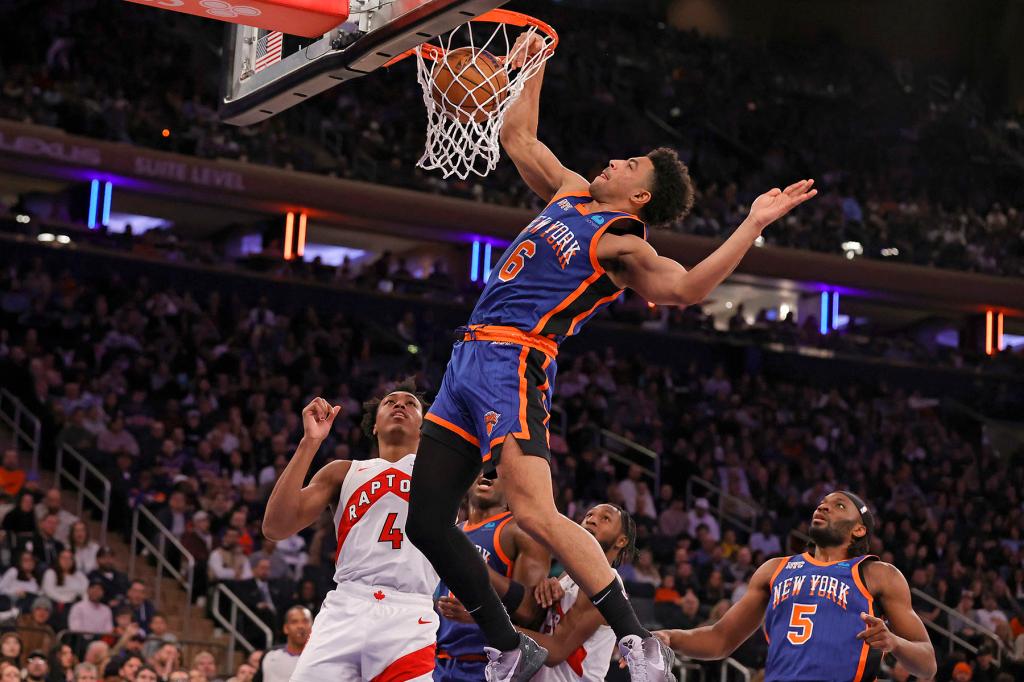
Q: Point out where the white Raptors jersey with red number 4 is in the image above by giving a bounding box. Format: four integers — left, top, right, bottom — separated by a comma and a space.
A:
334, 455, 438, 596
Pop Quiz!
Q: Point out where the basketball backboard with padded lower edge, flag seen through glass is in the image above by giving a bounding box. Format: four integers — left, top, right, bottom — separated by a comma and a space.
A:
221, 0, 507, 126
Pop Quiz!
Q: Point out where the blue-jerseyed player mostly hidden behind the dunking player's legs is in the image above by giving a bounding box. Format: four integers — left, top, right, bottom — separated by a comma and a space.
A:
434, 474, 551, 682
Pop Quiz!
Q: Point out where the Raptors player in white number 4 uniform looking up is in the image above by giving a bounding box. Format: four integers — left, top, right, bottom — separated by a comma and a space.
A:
263, 385, 438, 682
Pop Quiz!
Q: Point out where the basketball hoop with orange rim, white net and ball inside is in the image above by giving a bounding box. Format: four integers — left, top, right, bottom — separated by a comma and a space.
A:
416, 10, 558, 179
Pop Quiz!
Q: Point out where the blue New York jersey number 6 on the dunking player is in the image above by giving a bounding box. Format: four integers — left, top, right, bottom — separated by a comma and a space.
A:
469, 193, 647, 340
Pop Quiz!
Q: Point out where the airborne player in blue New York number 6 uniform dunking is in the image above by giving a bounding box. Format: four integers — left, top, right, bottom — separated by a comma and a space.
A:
408, 30, 815, 682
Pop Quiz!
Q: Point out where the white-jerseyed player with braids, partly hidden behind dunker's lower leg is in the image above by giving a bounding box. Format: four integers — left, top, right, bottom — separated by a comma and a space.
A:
438, 504, 637, 682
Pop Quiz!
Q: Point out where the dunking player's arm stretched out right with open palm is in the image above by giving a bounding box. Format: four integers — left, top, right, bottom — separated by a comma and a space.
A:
597, 180, 817, 305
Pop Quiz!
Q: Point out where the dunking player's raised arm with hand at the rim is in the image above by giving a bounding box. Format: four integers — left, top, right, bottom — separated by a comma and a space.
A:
501, 35, 589, 202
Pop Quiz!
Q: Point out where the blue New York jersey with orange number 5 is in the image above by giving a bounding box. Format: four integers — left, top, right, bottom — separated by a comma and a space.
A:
765, 553, 881, 682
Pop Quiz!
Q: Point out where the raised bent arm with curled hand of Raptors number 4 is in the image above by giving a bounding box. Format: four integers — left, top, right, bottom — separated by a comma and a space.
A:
263, 398, 351, 541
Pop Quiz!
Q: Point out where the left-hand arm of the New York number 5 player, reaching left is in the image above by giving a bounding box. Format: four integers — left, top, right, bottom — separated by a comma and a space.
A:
654, 558, 785, 660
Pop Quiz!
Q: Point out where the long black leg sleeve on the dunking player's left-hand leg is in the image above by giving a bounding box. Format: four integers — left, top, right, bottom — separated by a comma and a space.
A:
406, 433, 519, 651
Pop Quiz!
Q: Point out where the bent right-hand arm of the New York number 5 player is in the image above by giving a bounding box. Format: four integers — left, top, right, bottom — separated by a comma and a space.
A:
857, 561, 937, 679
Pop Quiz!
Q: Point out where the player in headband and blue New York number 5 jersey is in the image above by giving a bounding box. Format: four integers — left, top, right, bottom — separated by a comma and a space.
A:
655, 492, 936, 682
